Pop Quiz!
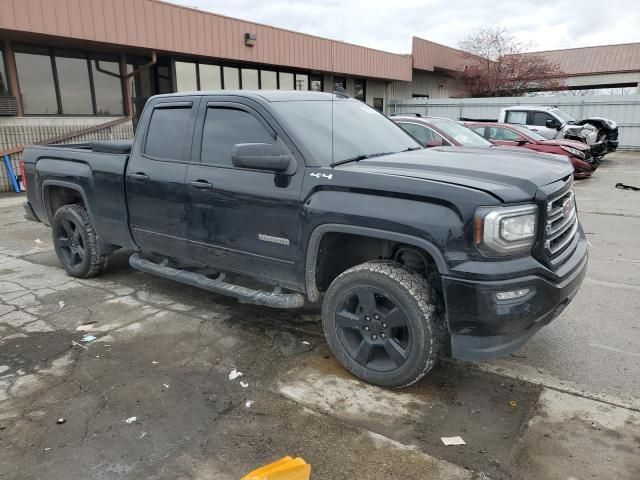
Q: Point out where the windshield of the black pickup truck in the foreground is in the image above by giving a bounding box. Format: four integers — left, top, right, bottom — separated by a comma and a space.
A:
272, 99, 422, 165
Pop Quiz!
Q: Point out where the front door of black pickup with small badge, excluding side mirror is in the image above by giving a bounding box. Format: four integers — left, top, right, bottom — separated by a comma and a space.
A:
186, 98, 304, 286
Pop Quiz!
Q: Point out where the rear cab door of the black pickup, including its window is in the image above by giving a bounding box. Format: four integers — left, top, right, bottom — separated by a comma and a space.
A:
127, 97, 199, 259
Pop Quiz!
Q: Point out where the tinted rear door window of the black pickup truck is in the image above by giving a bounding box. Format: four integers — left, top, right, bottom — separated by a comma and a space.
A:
144, 106, 191, 160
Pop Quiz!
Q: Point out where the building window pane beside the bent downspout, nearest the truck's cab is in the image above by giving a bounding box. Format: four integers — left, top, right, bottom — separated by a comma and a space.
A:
90, 55, 124, 115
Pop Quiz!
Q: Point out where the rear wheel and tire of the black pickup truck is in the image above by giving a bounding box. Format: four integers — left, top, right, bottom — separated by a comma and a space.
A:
51, 204, 109, 278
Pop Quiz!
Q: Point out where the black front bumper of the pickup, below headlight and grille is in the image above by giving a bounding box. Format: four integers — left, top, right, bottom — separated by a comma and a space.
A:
443, 232, 587, 360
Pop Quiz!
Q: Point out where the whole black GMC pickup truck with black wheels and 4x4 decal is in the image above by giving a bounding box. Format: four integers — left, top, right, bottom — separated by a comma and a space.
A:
23, 91, 587, 387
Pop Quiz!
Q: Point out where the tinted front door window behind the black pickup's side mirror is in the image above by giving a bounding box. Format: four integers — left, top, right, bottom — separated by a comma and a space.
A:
200, 107, 274, 165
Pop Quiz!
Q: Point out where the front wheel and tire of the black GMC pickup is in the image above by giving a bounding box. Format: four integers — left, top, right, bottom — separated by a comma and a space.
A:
322, 261, 443, 388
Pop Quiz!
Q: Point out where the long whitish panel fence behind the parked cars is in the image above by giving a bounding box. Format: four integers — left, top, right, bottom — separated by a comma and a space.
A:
389, 95, 640, 150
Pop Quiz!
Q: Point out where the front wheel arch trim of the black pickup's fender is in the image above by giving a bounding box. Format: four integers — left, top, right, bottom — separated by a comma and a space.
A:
305, 223, 449, 302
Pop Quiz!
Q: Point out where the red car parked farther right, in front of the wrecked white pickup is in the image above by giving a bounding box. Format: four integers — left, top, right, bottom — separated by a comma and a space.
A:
464, 122, 598, 178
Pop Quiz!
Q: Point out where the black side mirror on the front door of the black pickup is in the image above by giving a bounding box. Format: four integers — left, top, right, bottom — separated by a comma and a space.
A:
231, 143, 296, 175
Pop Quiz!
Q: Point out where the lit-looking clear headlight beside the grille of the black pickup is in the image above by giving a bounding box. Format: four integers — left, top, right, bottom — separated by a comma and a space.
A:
475, 205, 538, 255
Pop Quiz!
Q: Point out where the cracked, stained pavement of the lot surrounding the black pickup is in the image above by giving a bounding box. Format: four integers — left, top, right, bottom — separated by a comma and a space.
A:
0, 154, 640, 480
